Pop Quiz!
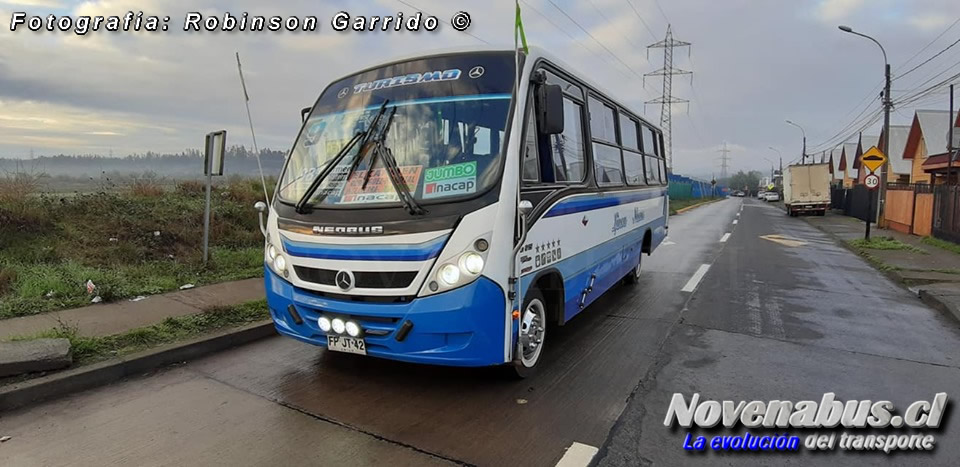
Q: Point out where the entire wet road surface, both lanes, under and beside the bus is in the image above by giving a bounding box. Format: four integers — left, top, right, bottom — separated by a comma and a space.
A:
0, 199, 960, 466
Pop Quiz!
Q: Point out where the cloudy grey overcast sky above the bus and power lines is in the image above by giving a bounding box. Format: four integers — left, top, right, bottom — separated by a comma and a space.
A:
0, 0, 960, 177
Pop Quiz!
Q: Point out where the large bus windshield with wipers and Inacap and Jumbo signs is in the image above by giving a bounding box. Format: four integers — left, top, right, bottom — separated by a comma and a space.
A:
279, 52, 514, 207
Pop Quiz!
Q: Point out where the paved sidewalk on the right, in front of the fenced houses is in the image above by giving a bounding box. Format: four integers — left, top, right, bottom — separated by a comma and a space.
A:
804, 213, 960, 320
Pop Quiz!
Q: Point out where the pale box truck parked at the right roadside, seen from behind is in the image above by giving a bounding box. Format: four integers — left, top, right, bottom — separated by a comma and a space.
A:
783, 164, 830, 216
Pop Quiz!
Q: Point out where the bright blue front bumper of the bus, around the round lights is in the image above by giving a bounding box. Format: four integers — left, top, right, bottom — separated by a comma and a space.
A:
264, 267, 507, 366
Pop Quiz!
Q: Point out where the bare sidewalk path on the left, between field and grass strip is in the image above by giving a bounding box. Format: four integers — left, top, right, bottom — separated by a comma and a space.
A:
0, 278, 264, 341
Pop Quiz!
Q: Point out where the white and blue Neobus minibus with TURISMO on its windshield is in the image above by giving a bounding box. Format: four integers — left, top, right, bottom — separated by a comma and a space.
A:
258, 48, 668, 376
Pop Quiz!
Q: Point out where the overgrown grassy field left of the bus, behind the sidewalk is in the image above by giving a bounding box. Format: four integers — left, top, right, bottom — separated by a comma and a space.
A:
0, 176, 263, 319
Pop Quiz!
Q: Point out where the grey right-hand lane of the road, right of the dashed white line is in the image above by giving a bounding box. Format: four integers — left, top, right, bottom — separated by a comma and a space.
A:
599, 200, 960, 466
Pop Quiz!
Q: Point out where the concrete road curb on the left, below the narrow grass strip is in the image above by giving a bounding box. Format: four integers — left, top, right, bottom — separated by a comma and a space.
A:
0, 321, 277, 412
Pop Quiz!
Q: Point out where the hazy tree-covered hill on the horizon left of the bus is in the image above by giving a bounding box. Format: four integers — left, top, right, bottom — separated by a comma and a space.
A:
0, 146, 285, 178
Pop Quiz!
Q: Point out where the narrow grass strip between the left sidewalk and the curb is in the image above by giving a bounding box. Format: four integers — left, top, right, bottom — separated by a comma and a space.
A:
11, 300, 270, 366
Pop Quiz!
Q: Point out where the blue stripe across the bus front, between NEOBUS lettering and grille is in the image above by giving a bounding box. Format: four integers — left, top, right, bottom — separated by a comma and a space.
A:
280, 235, 449, 261
